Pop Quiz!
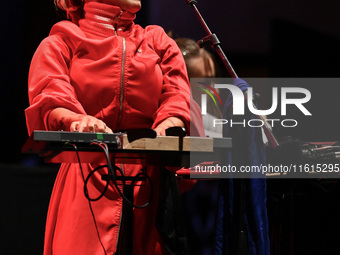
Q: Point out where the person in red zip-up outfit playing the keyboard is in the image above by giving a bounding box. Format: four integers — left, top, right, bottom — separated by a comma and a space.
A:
25, 0, 201, 255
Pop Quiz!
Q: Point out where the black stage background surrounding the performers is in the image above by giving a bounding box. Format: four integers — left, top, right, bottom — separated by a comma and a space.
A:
0, 0, 340, 254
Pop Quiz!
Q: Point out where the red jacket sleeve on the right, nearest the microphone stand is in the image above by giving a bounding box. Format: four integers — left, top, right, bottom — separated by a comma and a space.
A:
153, 27, 201, 135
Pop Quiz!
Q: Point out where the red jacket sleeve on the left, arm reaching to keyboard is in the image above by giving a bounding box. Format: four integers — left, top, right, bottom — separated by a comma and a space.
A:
25, 32, 85, 134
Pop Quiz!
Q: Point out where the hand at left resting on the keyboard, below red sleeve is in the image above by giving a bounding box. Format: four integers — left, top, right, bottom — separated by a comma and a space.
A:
70, 115, 113, 134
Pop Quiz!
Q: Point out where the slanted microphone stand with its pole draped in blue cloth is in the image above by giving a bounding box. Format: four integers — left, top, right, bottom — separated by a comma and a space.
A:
185, 0, 279, 255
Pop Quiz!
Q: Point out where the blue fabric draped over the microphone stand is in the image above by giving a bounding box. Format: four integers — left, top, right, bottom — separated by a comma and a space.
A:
215, 78, 270, 255
